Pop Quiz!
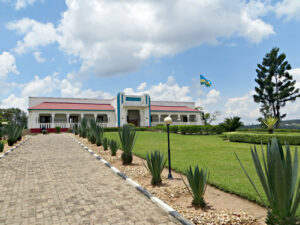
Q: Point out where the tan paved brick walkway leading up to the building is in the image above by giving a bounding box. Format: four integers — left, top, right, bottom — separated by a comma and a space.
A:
0, 134, 178, 225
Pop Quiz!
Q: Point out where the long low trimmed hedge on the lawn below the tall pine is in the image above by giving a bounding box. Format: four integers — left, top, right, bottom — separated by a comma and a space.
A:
225, 132, 300, 145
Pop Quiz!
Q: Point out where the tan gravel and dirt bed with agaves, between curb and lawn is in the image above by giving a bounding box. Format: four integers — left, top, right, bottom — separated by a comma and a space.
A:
72, 134, 267, 225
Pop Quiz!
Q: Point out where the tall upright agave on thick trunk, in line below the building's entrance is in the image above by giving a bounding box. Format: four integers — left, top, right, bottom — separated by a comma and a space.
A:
119, 124, 136, 164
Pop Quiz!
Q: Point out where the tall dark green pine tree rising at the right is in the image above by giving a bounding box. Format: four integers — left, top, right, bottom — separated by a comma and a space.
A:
253, 48, 300, 127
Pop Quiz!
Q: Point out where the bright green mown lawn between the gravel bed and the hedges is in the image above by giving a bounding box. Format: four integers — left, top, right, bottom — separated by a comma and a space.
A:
106, 131, 300, 215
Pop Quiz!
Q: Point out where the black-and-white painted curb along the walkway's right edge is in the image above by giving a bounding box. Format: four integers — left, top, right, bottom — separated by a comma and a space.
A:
69, 135, 194, 225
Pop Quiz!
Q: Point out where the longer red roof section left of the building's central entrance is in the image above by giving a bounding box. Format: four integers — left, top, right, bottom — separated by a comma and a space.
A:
29, 102, 114, 111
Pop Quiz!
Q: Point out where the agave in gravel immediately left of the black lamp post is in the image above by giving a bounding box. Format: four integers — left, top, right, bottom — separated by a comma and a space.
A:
146, 150, 167, 185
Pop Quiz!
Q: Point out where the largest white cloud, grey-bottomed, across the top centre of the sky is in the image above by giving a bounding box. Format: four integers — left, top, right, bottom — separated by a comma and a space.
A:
54, 0, 274, 75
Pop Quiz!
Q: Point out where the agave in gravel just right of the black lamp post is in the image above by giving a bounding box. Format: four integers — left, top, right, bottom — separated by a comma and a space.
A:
182, 166, 209, 208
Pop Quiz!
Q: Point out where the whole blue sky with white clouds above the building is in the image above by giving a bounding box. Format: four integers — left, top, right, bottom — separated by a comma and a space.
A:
0, 0, 300, 123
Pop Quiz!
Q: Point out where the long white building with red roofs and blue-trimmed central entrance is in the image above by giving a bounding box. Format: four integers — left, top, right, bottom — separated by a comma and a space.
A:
28, 93, 203, 132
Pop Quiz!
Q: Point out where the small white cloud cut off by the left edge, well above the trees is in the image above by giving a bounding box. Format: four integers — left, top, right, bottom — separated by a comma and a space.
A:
0, 52, 19, 78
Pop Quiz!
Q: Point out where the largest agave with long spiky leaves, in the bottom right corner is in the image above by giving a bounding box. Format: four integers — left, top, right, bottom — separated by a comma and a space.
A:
235, 138, 300, 225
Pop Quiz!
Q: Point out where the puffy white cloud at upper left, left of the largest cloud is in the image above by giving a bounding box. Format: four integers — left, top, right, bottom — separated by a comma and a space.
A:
7, 18, 59, 54
